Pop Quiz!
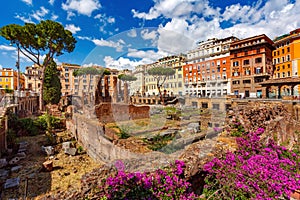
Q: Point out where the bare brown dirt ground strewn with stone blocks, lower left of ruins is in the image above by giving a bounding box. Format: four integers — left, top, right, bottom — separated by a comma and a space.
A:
0, 132, 102, 200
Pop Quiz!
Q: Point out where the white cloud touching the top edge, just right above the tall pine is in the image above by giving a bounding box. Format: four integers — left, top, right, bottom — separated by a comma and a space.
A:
62, 0, 101, 16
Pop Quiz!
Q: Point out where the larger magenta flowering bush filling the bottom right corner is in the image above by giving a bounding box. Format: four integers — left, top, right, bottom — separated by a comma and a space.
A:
204, 128, 300, 199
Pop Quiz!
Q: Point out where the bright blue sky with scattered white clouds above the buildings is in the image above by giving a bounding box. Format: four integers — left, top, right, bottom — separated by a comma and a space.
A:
0, 0, 300, 71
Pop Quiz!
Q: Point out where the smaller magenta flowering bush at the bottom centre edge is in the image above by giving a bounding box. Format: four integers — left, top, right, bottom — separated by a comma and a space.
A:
100, 161, 196, 200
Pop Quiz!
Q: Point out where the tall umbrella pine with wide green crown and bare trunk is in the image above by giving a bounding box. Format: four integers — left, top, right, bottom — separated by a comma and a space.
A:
0, 20, 77, 110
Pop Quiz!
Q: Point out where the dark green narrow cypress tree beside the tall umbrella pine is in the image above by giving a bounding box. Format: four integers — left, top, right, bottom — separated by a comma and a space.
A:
43, 59, 61, 104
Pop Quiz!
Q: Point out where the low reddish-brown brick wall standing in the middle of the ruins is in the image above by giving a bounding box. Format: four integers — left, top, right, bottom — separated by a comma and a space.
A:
95, 103, 150, 123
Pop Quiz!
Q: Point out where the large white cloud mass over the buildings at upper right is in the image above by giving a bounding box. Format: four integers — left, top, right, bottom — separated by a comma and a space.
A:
138, 0, 300, 49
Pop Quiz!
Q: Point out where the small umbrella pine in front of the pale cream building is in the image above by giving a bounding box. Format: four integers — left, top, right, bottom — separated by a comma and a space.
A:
147, 67, 175, 104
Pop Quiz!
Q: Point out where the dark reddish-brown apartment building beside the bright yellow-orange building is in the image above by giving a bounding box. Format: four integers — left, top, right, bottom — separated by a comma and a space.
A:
230, 34, 273, 97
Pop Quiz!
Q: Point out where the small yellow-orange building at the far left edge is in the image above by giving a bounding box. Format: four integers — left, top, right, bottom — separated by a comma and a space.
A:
0, 68, 25, 90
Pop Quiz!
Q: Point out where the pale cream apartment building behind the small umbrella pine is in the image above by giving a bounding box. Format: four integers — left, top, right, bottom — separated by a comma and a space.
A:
145, 55, 186, 95
